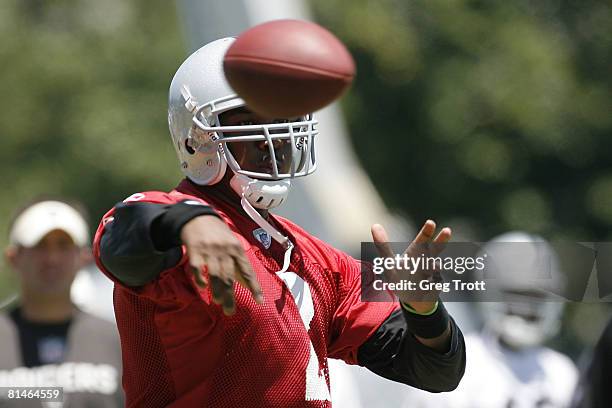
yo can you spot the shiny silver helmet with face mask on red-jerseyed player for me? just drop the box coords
[168,38,318,209]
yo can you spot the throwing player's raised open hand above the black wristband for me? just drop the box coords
[372,220,452,312]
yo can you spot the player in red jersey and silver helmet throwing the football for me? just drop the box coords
[94,38,465,407]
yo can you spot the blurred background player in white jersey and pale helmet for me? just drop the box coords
[402,232,577,408]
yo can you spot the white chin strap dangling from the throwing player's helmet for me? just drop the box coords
[230,174,293,273]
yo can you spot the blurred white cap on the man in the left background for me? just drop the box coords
[9,201,89,247]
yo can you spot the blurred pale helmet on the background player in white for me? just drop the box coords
[479,232,565,349]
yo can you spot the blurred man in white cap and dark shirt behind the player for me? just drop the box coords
[0,200,123,408]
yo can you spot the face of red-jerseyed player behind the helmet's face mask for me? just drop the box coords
[219,108,300,178]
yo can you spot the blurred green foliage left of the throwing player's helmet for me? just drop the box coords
[0,0,185,295]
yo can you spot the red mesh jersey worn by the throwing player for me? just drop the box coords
[94,181,397,408]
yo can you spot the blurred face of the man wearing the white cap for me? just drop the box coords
[7,230,85,294]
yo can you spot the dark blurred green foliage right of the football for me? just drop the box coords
[316,0,612,240]
